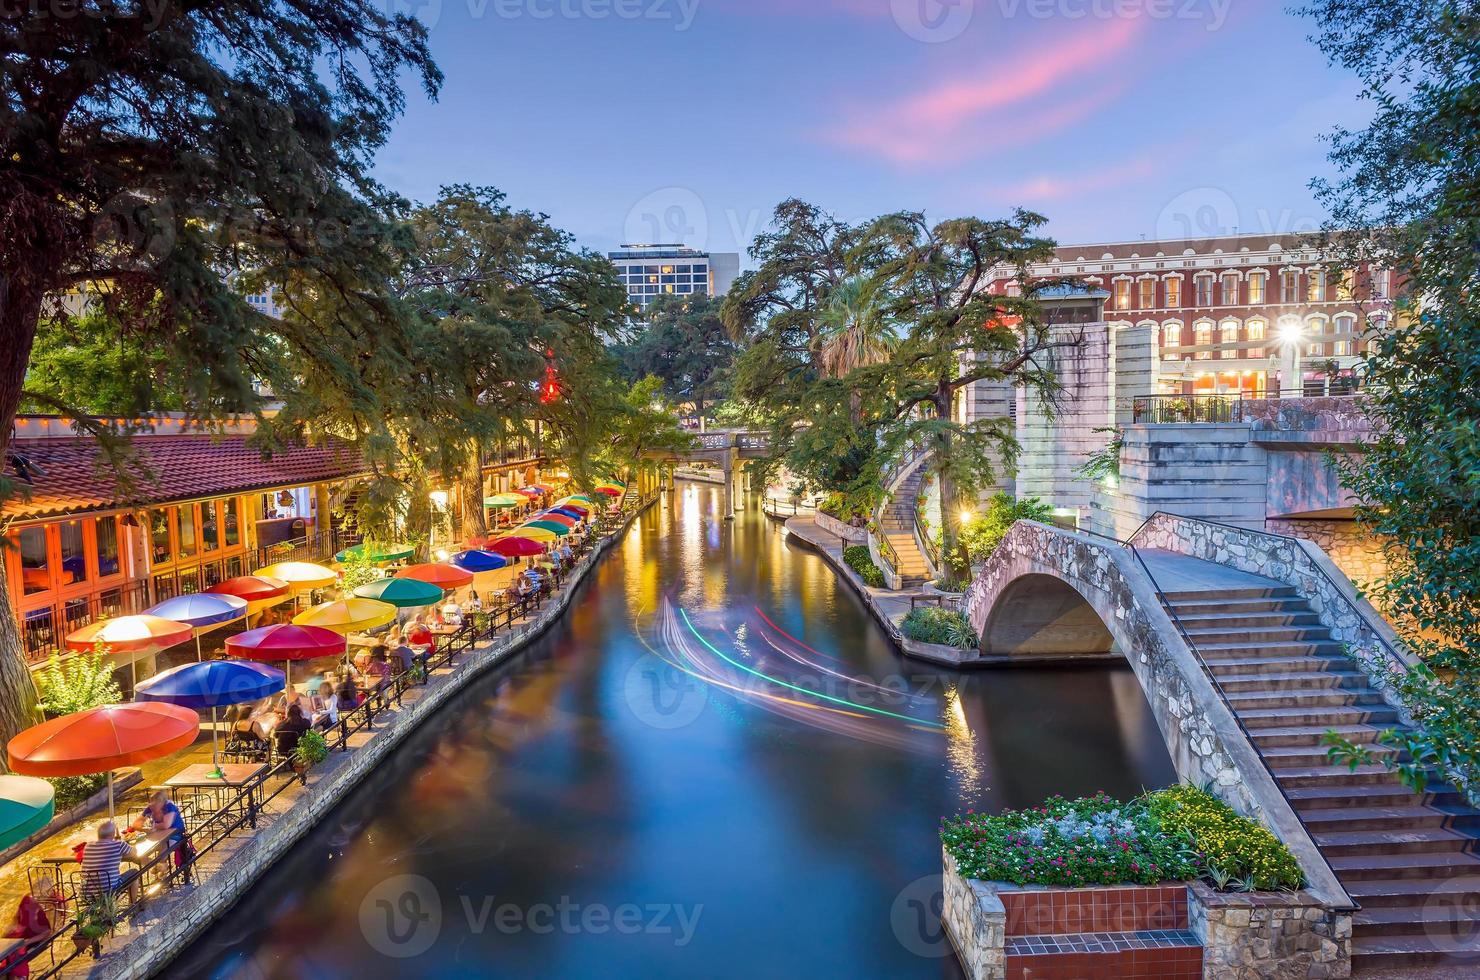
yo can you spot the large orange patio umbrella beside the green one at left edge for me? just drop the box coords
[7,702,200,820]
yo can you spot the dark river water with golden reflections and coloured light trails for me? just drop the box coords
[170,484,1172,977]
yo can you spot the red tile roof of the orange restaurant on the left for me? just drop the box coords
[0,434,367,520]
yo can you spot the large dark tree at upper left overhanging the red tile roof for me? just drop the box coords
[0,0,440,739]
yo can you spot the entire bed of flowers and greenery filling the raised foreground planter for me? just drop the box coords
[940,786,1302,891]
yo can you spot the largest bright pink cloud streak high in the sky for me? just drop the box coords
[824,18,1144,164]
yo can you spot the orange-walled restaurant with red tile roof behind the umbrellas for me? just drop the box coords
[0,416,540,675]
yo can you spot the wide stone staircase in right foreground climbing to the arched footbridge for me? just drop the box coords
[1153,568,1480,976]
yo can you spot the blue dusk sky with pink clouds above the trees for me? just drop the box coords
[377,0,1365,264]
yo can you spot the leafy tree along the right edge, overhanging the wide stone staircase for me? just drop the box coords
[1304,0,1480,791]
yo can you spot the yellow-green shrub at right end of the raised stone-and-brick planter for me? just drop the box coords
[1147,786,1305,891]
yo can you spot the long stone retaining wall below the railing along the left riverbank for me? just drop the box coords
[101,497,657,980]
